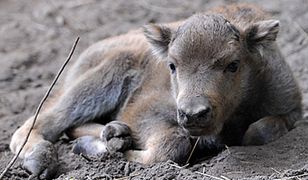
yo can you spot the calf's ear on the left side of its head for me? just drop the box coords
[143,24,172,59]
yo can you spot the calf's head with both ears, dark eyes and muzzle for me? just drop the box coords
[144,14,279,136]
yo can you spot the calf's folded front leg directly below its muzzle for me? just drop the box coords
[125,122,191,164]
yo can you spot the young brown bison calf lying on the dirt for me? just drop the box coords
[10,5,301,178]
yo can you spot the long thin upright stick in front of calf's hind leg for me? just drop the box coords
[0,37,80,180]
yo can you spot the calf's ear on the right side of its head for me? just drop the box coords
[245,20,279,50]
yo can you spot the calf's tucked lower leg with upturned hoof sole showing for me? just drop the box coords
[68,121,132,156]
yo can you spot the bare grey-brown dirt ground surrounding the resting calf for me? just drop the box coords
[0,0,308,179]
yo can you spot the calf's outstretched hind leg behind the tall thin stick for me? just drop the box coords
[10,58,136,176]
